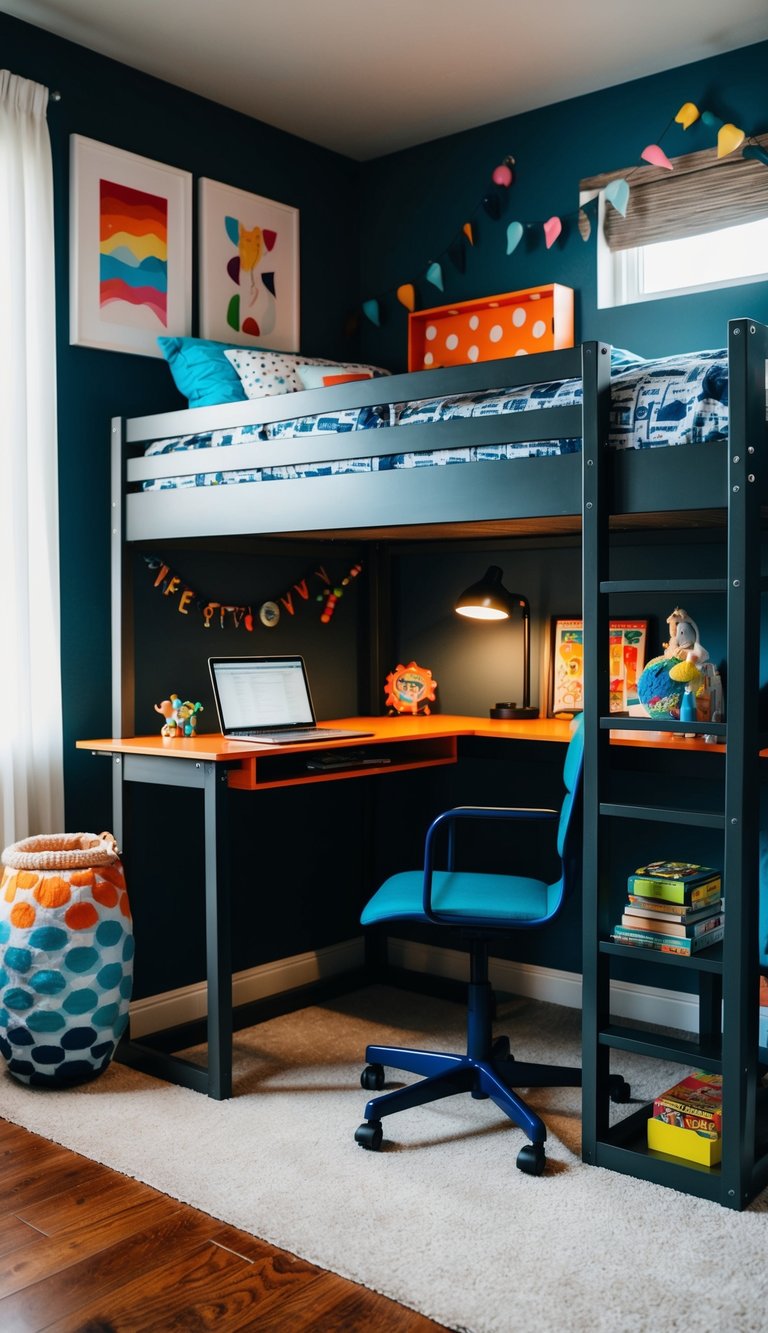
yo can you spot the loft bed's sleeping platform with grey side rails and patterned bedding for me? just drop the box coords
[113,332,740,541]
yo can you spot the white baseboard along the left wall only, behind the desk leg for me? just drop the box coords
[131,937,365,1040]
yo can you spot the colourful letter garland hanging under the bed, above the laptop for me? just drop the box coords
[144,556,363,633]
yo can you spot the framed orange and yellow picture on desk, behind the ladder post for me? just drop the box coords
[547,616,648,717]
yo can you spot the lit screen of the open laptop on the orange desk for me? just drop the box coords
[209,657,315,733]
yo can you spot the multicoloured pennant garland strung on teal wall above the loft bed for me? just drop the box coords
[360,101,768,327]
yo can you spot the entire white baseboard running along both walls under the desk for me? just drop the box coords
[131,937,699,1040]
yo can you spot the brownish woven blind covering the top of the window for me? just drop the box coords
[580,135,768,249]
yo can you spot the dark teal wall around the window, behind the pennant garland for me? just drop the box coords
[361,43,768,369]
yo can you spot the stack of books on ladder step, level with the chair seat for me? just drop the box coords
[611,861,725,956]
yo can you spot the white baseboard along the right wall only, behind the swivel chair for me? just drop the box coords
[387,938,699,1032]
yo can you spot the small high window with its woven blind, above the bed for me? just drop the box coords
[580,136,768,308]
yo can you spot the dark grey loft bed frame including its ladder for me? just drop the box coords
[112,319,768,1208]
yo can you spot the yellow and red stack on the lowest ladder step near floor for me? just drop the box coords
[648,1069,723,1166]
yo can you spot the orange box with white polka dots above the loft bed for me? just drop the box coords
[408,283,573,371]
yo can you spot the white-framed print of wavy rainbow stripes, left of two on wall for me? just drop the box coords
[69,135,192,357]
